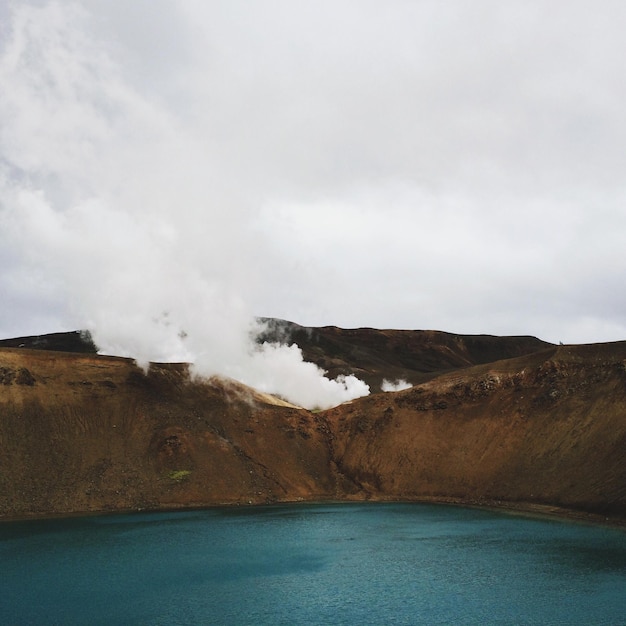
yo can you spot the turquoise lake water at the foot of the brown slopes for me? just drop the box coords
[0,504,626,626]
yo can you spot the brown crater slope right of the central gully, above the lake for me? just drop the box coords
[326,342,626,518]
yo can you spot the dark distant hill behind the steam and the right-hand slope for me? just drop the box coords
[259,318,552,393]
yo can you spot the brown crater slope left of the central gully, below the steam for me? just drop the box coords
[0,349,335,517]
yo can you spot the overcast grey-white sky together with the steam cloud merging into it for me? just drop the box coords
[0,0,626,404]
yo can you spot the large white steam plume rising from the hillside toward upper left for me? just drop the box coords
[0,2,369,408]
